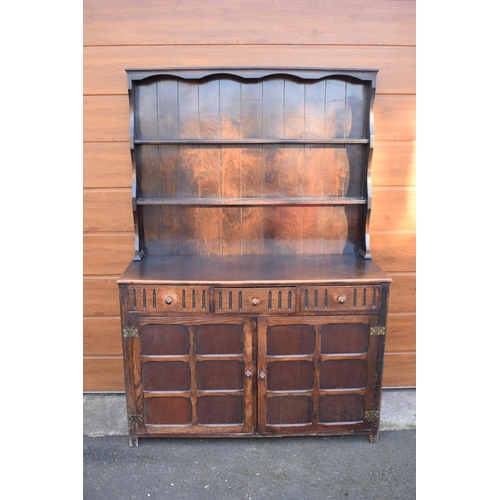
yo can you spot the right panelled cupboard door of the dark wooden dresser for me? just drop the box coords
[257,315,382,434]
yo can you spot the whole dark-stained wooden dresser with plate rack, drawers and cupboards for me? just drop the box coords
[118,68,391,444]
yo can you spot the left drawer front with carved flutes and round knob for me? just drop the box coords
[129,286,210,313]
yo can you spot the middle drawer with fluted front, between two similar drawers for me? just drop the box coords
[214,287,296,314]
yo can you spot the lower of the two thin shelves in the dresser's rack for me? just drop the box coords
[136,197,368,206]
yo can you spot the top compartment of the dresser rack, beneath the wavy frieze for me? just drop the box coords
[131,75,373,145]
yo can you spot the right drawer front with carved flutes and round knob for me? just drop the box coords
[300,285,381,312]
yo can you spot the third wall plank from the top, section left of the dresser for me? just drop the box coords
[83,96,130,142]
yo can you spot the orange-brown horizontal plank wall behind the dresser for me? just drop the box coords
[83,0,416,392]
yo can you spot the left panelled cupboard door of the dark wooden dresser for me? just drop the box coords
[138,317,255,435]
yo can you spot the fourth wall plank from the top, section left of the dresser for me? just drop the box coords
[83,142,132,189]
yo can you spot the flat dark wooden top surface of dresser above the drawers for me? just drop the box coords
[118,254,392,285]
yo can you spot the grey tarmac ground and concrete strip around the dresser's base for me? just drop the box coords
[83,390,416,500]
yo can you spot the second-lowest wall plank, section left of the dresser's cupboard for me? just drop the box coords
[83,318,122,356]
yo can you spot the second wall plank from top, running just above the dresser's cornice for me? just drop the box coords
[83,45,416,95]
